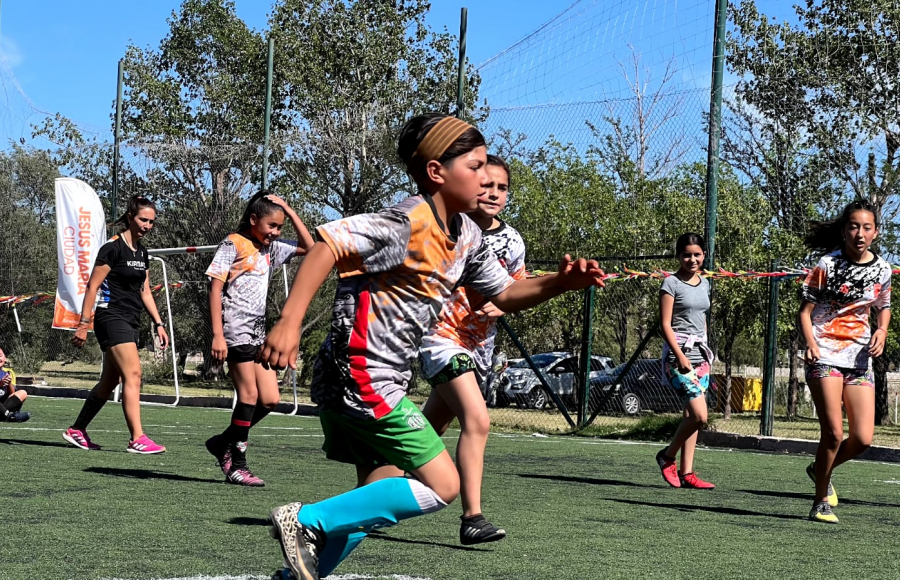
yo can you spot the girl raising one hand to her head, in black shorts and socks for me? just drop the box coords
[206,191,313,487]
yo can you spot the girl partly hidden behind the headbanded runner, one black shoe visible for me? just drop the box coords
[418,155,525,546]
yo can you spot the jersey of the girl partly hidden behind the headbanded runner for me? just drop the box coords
[419,222,527,380]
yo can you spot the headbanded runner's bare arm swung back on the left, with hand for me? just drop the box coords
[256,242,335,369]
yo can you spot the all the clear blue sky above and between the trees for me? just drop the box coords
[0,0,787,141]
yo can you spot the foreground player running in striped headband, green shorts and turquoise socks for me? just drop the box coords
[259,113,602,580]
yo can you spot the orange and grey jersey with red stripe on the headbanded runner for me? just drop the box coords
[312,195,513,419]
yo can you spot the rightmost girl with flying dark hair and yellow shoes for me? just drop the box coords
[800,200,891,523]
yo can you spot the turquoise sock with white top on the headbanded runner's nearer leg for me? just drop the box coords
[297,477,447,545]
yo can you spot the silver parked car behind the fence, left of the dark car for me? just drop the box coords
[497,352,613,409]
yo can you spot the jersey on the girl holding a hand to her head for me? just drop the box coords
[206,234,297,346]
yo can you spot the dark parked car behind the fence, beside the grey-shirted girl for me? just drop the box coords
[591,358,684,415]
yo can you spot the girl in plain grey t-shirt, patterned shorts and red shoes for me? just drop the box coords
[656,233,715,489]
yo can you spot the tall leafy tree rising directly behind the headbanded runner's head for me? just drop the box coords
[270,0,484,216]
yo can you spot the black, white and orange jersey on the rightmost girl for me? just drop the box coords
[802,250,891,369]
